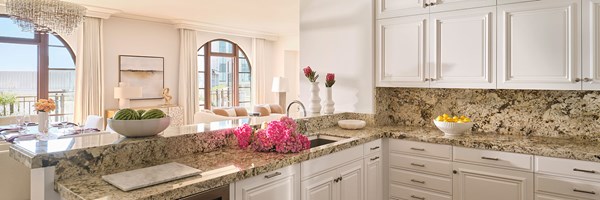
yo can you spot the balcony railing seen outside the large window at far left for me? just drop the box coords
[0,91,75,122]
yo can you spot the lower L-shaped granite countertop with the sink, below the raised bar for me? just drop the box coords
[56,125,600,200]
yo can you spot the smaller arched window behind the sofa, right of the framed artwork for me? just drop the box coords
[198,39,252,109]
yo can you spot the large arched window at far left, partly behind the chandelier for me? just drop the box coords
[0,15,75,121]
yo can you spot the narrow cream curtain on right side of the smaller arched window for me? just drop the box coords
[252,38,271,105]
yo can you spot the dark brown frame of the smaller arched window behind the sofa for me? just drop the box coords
[197,39,252,109]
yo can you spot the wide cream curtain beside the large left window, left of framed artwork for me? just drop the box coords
[74,17,104,123]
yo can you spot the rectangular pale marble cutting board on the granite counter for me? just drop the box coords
[102,162,202,192]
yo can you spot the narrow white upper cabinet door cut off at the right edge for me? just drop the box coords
[582,0,600,90]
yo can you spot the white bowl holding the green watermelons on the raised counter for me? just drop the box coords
[108,117,171,138]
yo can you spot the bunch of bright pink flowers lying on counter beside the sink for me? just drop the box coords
[233,117,310,153]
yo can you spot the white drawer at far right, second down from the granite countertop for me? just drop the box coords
[535,175,600,199]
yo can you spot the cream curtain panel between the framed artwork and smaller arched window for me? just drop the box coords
[178,29,200,124]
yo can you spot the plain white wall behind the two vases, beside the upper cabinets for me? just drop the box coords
[299,0,374,113]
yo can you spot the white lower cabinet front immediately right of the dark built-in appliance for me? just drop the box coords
[235,164,300,200]
